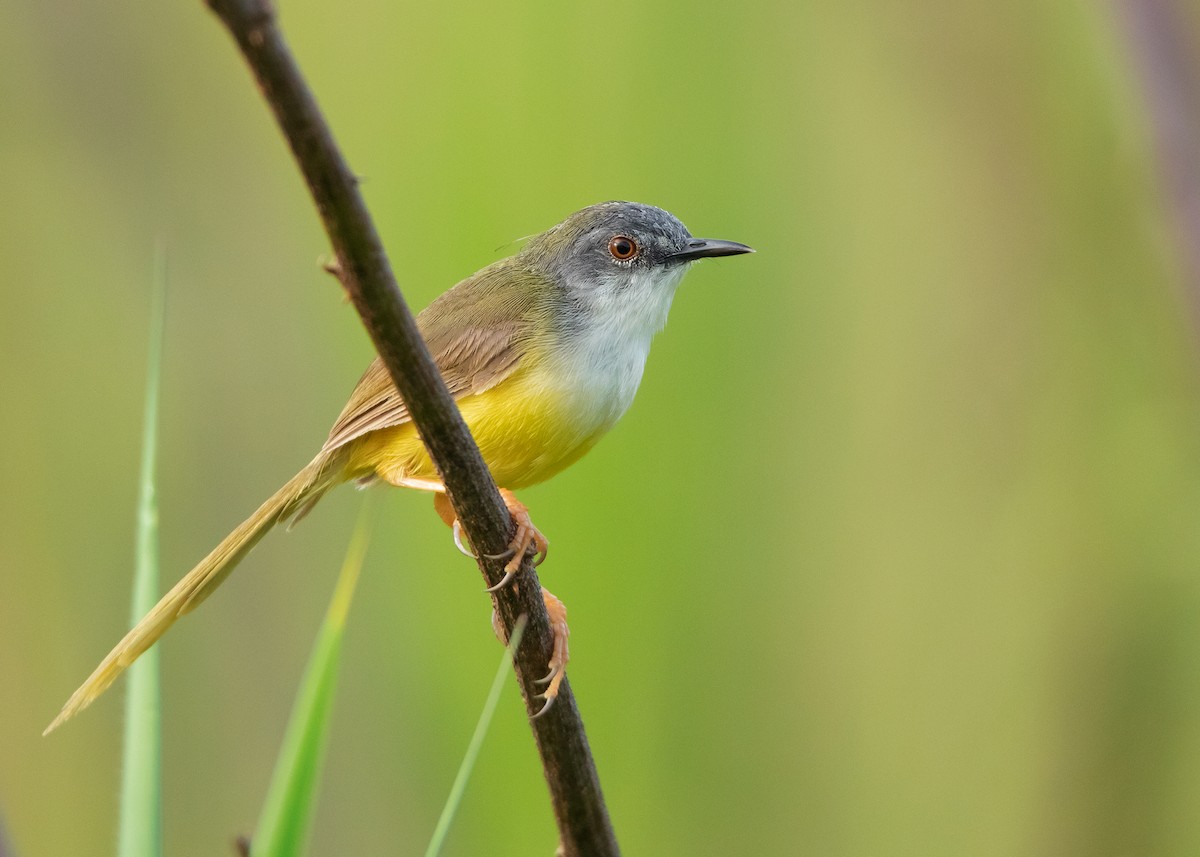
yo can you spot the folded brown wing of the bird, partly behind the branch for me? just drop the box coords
[322,259,540,451]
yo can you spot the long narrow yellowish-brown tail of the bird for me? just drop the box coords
[42,451,344,735]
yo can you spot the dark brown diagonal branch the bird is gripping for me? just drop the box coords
[206,0,619,856]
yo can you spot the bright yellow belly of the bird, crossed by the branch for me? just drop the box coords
[348,370,616,489]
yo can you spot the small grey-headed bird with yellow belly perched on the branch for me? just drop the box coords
[44,202,754,735]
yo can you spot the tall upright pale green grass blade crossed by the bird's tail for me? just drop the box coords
[116,238,167,857]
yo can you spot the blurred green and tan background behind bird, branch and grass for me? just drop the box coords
[0,0,1200,857]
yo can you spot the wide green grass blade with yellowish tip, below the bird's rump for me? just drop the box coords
[250,498,373,857]
